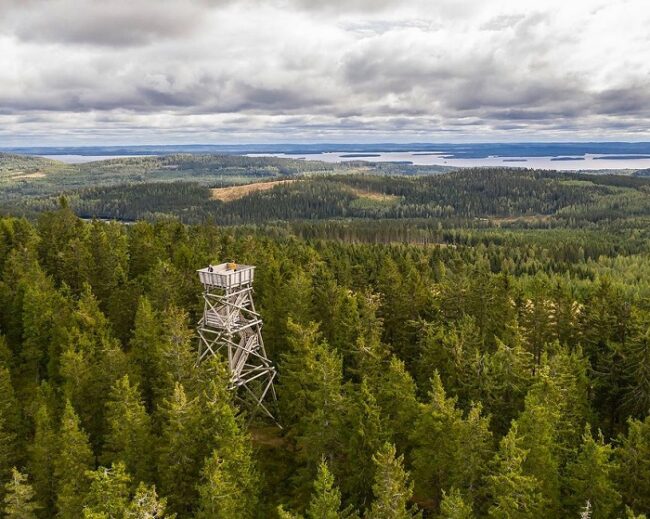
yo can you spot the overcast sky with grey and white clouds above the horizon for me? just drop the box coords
[0,0,650,146]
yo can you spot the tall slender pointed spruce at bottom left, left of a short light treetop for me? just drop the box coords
[54,401,94,519]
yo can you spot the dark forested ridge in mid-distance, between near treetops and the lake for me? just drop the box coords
[10,168,650,226]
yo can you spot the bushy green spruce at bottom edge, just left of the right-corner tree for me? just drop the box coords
[567,425,621,519]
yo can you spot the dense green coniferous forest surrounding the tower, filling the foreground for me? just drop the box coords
[0,164,650,519]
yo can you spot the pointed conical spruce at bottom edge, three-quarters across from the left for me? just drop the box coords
[487,422,544,519]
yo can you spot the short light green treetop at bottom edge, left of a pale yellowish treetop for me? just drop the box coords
[83,463,131,519]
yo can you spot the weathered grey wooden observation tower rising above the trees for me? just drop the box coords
[197,263,276,420]
